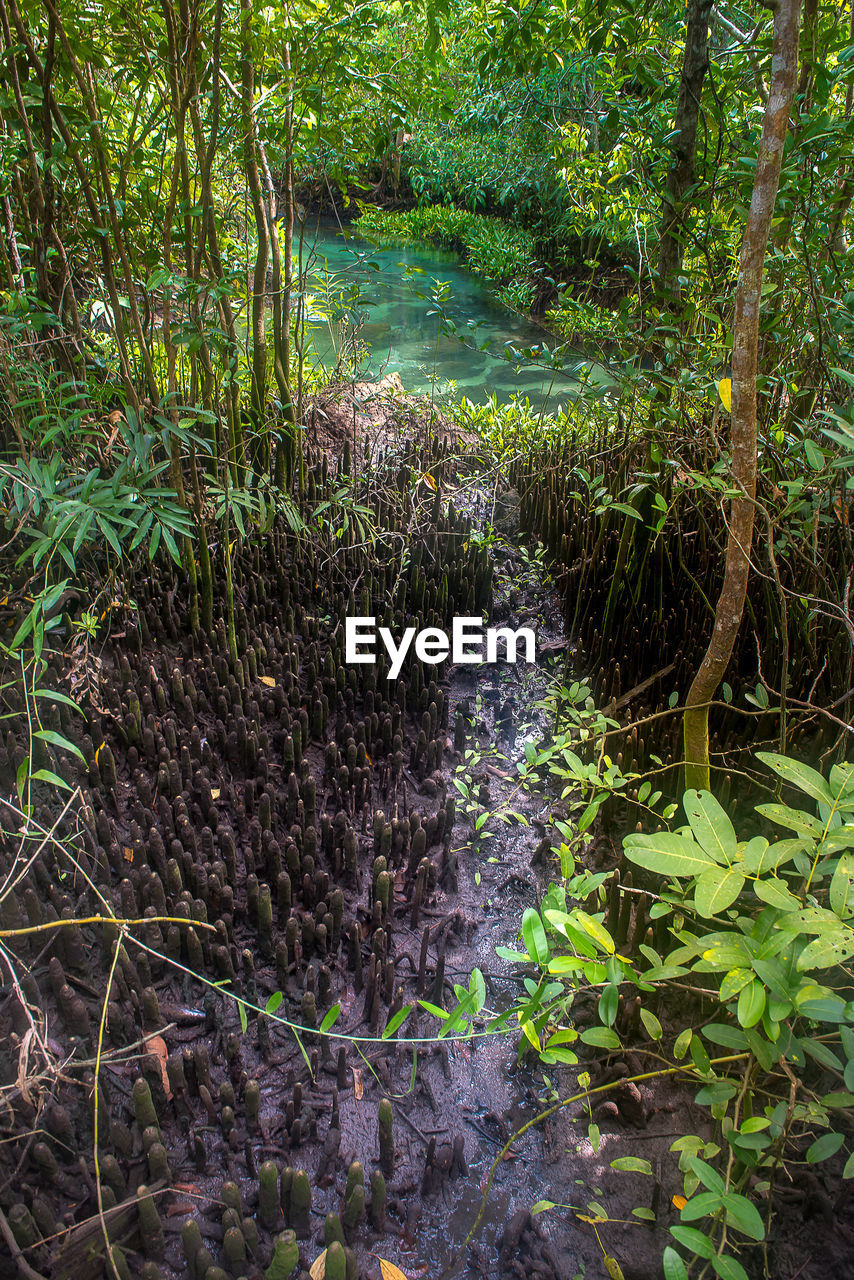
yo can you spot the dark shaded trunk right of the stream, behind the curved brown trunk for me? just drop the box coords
[658,0,712,303]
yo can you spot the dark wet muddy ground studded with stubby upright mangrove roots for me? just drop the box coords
[0,388,850,1280]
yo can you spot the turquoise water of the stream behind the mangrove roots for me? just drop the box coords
[303,229,609,408]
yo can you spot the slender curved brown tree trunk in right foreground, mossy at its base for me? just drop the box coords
[684,0,800,787]
